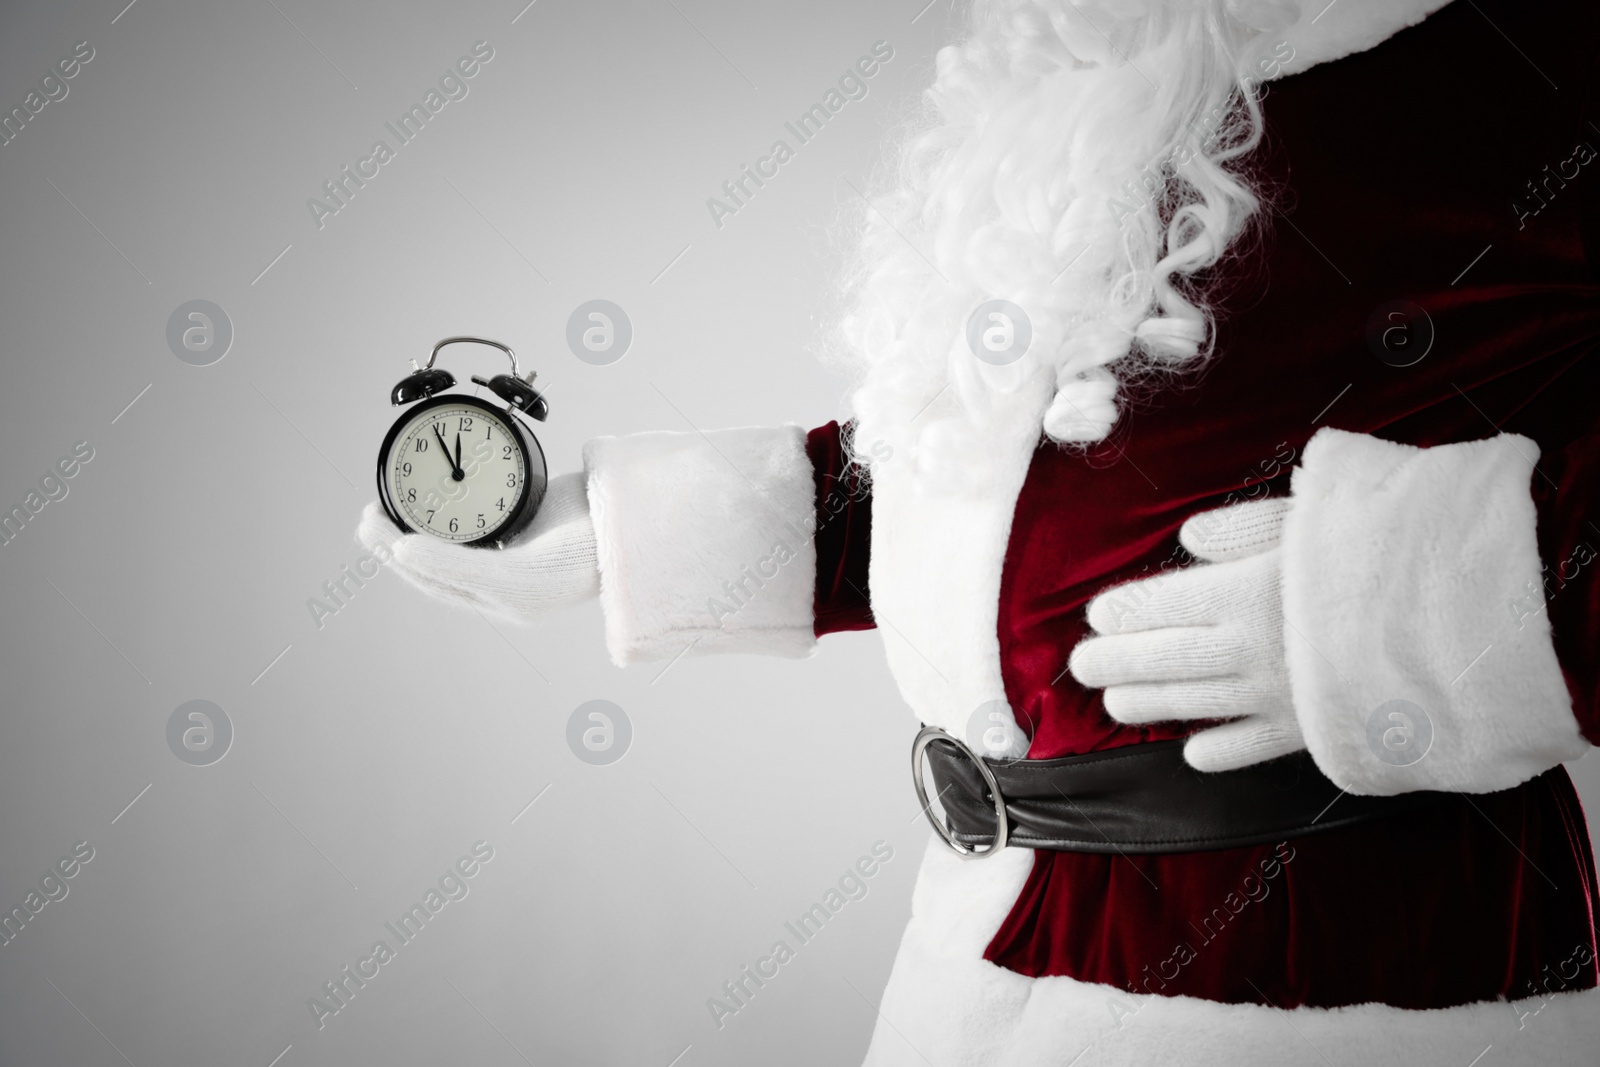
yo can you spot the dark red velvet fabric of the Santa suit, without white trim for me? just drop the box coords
[808,0,1600,1008]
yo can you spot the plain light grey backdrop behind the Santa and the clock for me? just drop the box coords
[0,0,1600,1067]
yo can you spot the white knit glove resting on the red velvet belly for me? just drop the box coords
[1069,499,1306,771]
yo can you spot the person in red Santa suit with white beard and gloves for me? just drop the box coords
[362,0,1600,1067]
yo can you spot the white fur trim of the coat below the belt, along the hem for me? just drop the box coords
[864,840,1600,1067]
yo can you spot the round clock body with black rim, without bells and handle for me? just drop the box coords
[379,397,546,544]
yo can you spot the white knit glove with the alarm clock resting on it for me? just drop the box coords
[357,474,600,621]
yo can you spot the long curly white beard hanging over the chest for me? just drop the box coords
[830,0,1299,478]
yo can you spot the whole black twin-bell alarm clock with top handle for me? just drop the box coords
[378,338,550,547]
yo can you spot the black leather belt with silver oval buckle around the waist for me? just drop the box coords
[910,726,1451,857]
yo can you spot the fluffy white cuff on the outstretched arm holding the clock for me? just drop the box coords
[584,426,816,665]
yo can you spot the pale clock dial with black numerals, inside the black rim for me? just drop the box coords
[389,405,526,541]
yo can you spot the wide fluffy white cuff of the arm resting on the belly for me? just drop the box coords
[1283,429,1589,795]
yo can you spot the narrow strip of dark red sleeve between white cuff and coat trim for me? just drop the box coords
[805,422,877,637]
